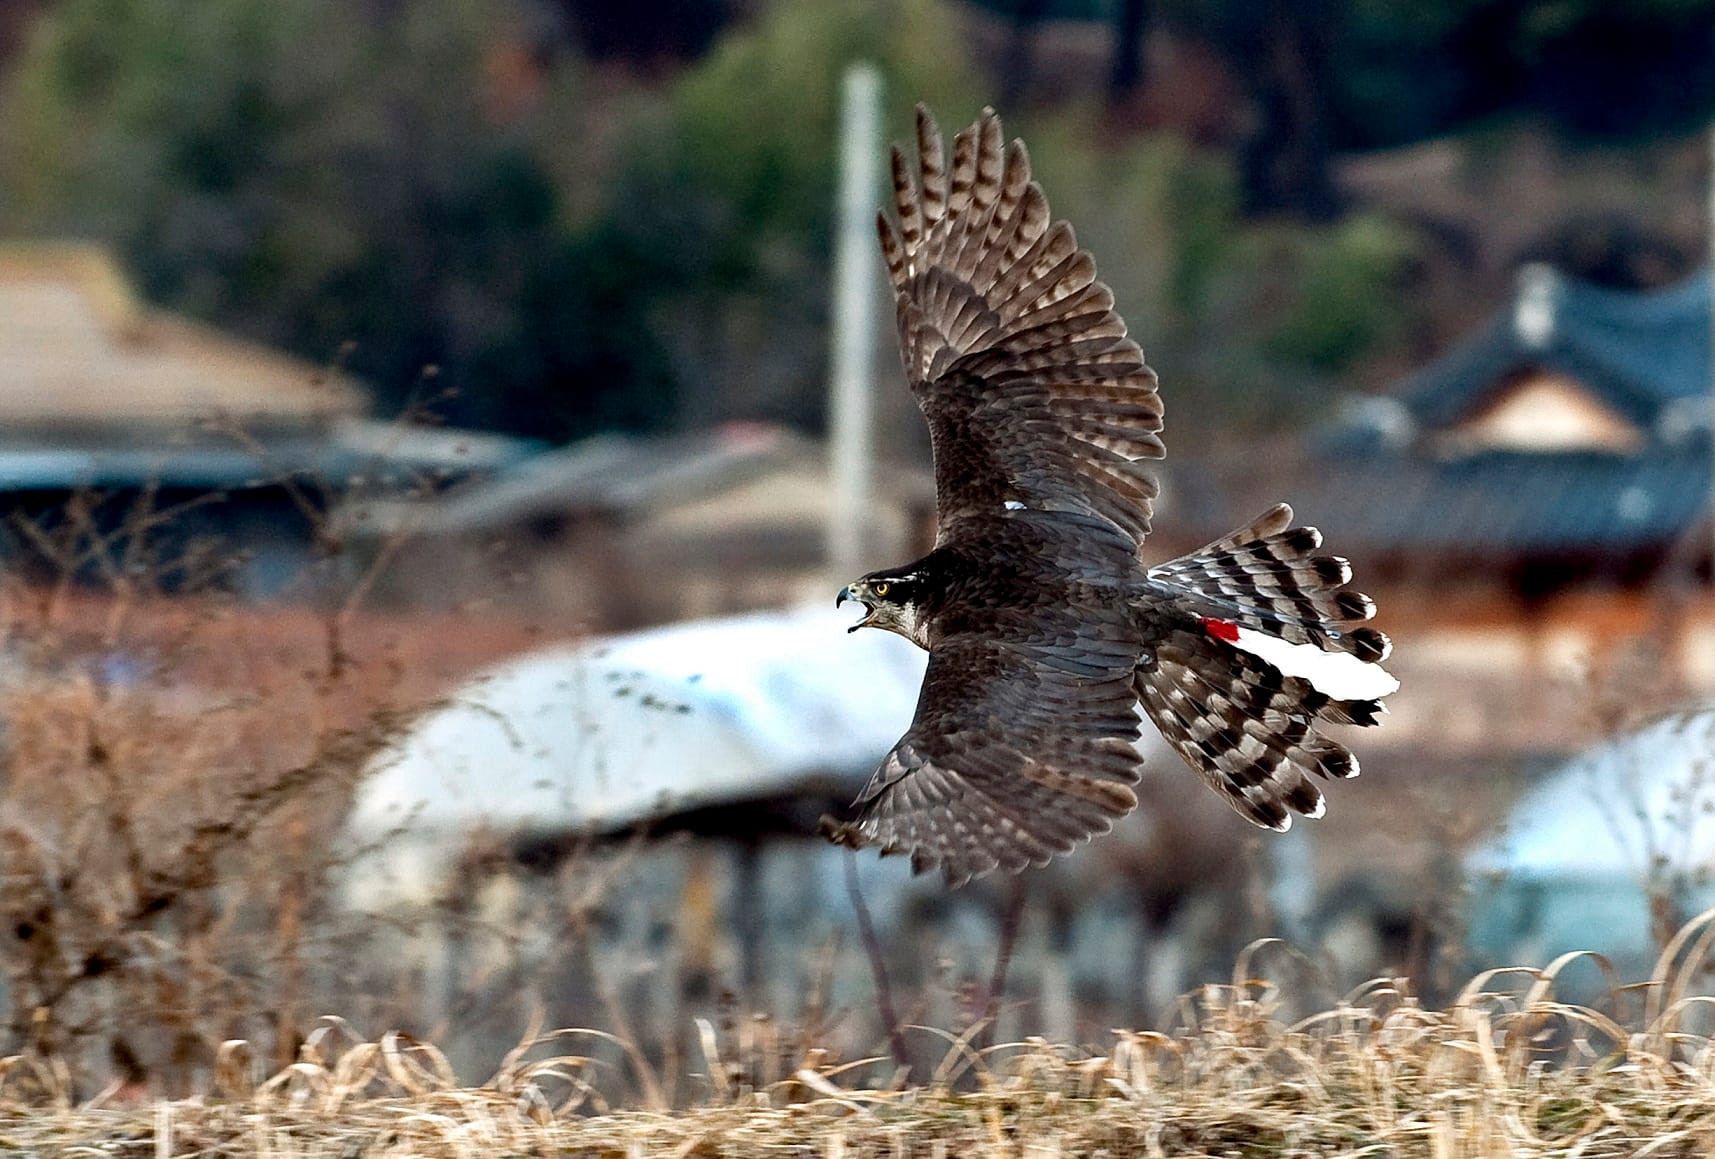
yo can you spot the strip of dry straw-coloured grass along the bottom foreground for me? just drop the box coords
[10,914,1715,1159]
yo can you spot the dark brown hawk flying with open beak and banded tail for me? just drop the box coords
[823,106,1398,885]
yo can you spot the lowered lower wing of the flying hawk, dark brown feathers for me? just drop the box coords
[840,614,1139,885]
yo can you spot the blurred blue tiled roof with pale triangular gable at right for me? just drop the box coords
[1298,266,1715,580]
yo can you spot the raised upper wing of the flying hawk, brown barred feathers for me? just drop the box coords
[880,105,1163,542]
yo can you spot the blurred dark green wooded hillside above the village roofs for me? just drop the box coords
[10,0,1715,441]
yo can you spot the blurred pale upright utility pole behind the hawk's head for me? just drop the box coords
[827,63,882,583]
